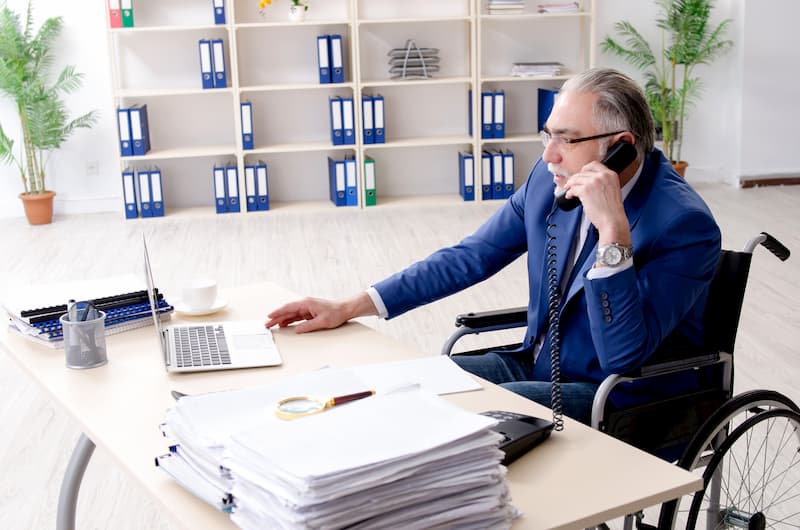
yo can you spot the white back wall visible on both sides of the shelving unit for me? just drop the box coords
[0,0,800,217]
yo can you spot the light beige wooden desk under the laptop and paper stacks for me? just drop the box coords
[0,284,702,529]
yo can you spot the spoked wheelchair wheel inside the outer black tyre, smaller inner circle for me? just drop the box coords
[686,409,800,530]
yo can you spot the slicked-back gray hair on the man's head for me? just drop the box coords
[561,68,655,157]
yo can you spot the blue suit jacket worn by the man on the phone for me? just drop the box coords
[374,150,720,398]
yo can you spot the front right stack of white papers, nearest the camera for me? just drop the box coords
[224,389,516,529]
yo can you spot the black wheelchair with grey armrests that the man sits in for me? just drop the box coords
[442,232,800,530]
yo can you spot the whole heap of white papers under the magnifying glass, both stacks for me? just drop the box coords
[157,359,518,528]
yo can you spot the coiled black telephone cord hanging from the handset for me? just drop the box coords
[545,205,564,431]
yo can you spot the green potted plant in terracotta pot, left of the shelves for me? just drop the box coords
[0,2,96,224]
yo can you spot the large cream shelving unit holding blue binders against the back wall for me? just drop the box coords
[103,0,594,215]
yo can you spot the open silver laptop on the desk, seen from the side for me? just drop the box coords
[142,235,282,372]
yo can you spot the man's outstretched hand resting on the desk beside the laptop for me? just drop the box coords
[266,293,378,333]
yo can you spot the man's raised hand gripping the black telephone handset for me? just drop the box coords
[566,162,631,245]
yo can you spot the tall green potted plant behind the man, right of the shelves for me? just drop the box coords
[600,0,733,176]
